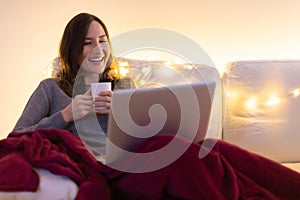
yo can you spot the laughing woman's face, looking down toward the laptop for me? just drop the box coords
[78,21,111,74]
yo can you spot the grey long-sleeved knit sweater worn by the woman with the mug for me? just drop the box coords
[13,78,108,156]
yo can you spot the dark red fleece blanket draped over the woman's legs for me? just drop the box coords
[0,129,300,200]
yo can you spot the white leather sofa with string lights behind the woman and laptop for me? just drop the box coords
[114,59,300,172]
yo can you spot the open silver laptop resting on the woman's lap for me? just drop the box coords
[105,81,216,163]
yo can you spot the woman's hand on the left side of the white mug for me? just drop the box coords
[61,89,93,123]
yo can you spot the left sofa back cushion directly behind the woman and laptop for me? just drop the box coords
[43,57,223,139]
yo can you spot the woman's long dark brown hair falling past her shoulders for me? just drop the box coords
[56,13,117,97]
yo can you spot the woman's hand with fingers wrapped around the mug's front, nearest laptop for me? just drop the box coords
[94,90,112,114]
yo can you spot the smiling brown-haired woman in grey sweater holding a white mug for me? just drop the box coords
[13,13,132,156]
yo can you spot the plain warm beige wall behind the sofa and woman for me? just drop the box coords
[0,0,300,138]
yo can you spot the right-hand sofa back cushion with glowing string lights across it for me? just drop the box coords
[222,60,300,162]
